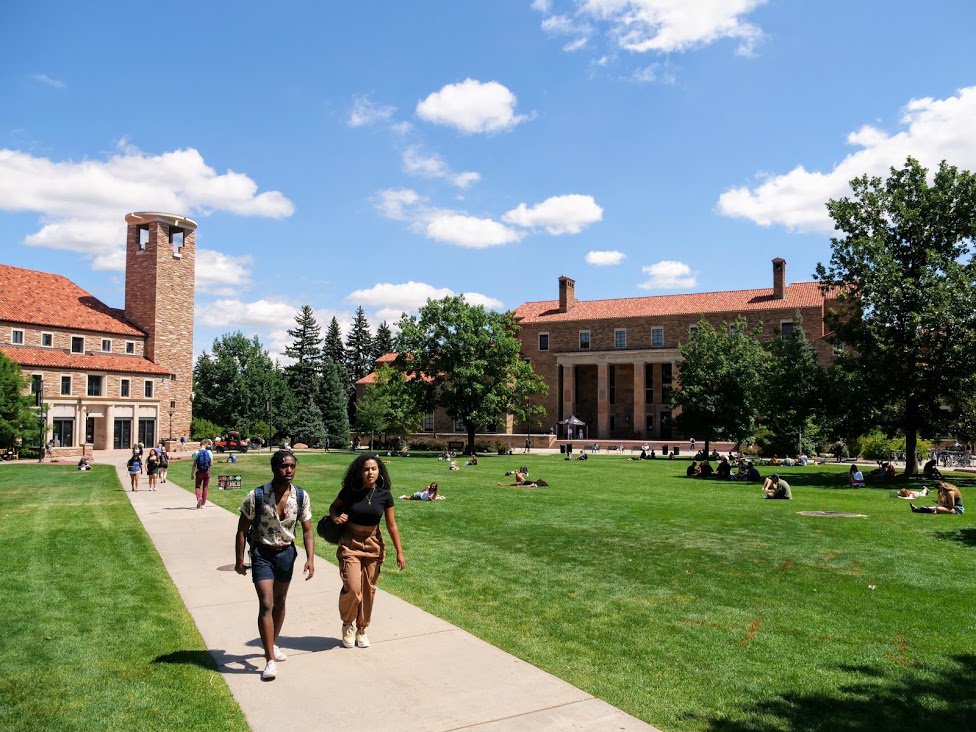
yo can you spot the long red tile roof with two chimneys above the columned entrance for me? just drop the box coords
[514,282,823,323]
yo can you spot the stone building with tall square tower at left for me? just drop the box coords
[0,212,197,455]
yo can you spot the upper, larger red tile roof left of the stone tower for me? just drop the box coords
[0,264,146,337]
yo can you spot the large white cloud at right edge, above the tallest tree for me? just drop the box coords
[718,86,976,231]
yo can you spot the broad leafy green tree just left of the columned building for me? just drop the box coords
[396,296,547,452]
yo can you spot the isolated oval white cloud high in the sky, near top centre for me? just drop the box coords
[417,79,528,134]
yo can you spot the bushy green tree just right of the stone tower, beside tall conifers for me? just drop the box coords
[193,331,294,437]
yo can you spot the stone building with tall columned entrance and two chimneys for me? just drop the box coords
[514,258,833,440]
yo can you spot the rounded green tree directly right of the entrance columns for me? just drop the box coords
[671,319,768,460]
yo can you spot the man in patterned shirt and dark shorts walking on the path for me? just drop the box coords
[234,450,315,681]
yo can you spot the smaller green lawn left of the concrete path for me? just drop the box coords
[0,465,247,730]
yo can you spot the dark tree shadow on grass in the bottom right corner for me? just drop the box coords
[703,654,976,732]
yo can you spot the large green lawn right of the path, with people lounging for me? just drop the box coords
[202,453,976,731]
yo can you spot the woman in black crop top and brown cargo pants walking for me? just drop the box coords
[329,455,407,648]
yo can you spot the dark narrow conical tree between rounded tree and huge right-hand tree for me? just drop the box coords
[762,312,824,455]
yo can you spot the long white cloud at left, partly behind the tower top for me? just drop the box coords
[0,145,294,270]
